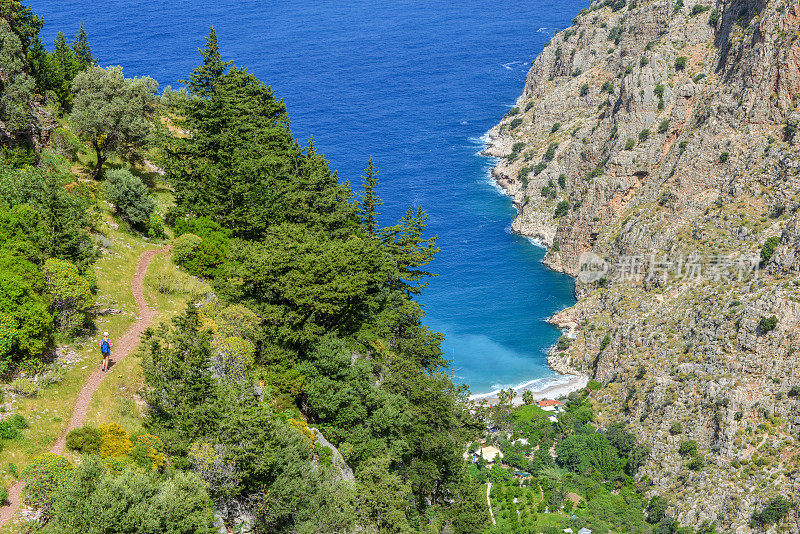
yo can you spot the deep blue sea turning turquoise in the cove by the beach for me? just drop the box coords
[34,0,588,393]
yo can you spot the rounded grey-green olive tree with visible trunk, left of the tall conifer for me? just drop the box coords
[70,67,158,177]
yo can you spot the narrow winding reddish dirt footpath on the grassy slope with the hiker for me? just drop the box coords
[0,247,170,526]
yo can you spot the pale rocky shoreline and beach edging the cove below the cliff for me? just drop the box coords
[469,126,589,406]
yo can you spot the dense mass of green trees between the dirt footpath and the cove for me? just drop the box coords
[144,30,487,532]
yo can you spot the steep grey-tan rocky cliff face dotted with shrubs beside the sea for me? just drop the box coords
[487,0,800,532]
